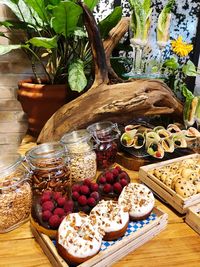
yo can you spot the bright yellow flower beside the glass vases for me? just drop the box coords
[171,36,193,57]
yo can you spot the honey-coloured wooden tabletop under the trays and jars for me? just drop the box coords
[0,136,200,267]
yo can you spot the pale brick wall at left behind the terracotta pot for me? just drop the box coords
[0,5,28,154]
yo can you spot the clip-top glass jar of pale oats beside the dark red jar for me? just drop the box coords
[61,129,97,183]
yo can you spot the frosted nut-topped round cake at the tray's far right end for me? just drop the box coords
[118,183,155,221]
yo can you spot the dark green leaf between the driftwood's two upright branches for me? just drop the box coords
[98,6,122,39]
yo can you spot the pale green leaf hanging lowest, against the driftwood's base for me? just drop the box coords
[68,59,87,92]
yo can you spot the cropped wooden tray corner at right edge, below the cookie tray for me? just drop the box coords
[185,204,200,234]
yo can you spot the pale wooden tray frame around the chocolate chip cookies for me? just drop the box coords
[139,154,200,214]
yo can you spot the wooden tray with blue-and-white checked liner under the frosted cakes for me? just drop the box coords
[32,208,168,267]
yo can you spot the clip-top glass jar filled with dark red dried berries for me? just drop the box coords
[87,121,120,170]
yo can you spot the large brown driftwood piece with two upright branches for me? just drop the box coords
[38,4,183,143]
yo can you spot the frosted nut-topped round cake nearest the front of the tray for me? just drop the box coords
[56,213,103,266]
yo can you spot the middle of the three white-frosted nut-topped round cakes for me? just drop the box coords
[90,200,129,241]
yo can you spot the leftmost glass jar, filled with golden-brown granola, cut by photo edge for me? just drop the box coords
[0,153,32,233]
